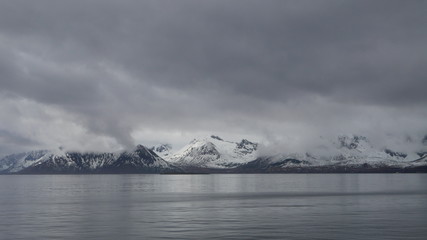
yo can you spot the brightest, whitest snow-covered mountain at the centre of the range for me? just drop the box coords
[165,135,258,169]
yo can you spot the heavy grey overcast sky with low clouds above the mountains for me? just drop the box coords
[0,0,427,155]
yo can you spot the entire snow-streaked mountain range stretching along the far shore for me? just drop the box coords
[0,135,427,174]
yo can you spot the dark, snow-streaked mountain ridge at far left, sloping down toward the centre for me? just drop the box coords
[0,145,178,173]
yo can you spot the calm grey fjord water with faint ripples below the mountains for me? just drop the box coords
[0,174,427,240]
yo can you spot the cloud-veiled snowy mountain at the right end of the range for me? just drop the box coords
[241,135,427,172]
